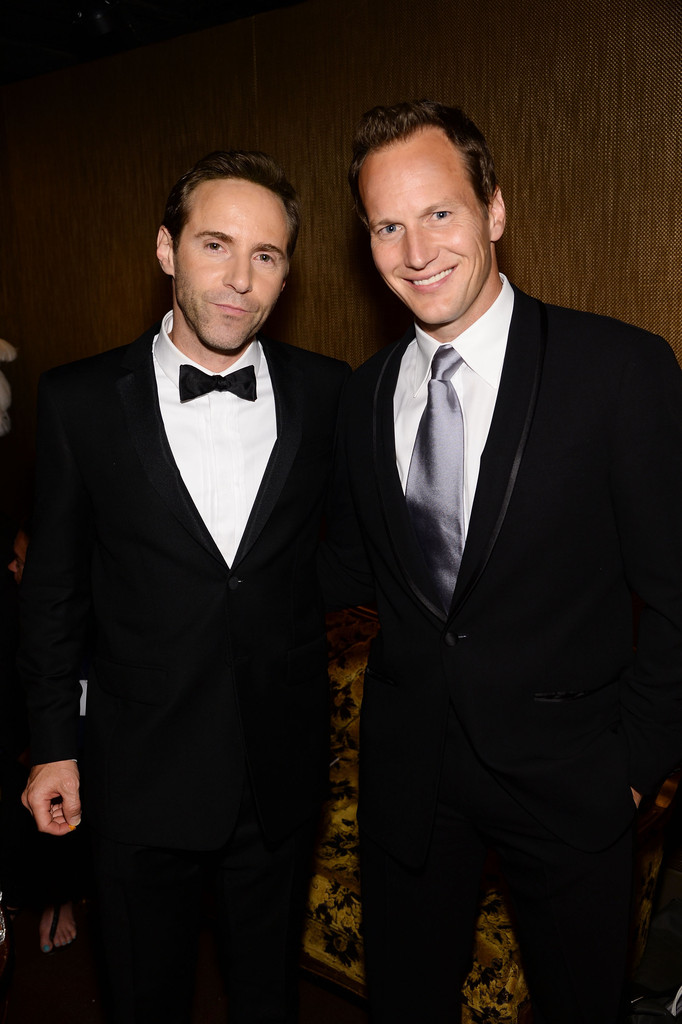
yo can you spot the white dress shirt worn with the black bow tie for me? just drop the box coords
[154,311,276,565]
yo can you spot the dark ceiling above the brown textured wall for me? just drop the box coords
[0,0,296,85]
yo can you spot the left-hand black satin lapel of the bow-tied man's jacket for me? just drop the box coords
[116,328,225,565]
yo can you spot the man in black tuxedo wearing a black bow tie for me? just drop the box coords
[20,151,348,1024]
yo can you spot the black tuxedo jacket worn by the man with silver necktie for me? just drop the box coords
[323,291,682,864]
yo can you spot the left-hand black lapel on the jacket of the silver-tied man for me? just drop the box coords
[373,328,445,622]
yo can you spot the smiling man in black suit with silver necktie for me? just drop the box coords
[323,100,682,1024]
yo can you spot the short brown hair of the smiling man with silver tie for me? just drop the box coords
[348,99,498,227]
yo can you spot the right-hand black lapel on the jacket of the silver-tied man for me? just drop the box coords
[449,289,547,618]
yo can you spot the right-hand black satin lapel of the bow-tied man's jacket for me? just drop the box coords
[235,338,301,565]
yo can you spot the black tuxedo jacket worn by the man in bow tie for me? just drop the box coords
[20,329,349,849]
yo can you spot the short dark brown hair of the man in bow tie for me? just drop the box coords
[163,150,301,258]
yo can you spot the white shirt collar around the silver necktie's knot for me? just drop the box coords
[414,273,514,395]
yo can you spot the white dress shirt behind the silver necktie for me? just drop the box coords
[393,273,514,537]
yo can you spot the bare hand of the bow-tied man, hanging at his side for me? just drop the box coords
[22,761,81,836]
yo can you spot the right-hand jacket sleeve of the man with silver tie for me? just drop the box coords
[611,338,682,793]
